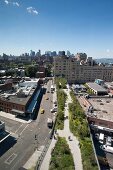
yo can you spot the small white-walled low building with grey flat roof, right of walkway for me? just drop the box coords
[86,82,108,95]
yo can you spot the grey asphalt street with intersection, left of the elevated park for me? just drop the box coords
[0,81,53,170]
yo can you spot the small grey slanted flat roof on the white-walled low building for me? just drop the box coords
[87,82,107,92]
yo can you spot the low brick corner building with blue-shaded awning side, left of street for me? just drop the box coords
[0,79,41,116]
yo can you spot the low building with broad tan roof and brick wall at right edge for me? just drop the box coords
[85,98,113,131]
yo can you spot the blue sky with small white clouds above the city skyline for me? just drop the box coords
[0,0,113,58]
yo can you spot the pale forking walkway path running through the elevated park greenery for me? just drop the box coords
[40,89,83,170]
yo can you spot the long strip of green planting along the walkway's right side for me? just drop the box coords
[69,92,98,170]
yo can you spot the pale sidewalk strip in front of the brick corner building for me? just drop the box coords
[0,111,32,123]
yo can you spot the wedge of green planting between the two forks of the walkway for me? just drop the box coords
[49,137,75,170]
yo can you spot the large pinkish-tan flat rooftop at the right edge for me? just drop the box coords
[88,98,113,121]
